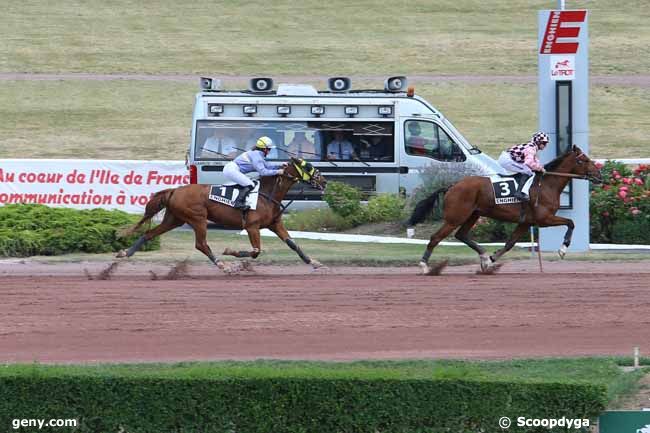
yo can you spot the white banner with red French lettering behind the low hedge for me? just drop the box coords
[0,159,190,213]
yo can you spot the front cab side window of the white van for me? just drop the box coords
[404,120,466,162]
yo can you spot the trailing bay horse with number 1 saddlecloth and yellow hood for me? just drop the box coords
[117,157,327,273]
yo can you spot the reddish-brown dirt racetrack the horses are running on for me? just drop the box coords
[0,260,650,362]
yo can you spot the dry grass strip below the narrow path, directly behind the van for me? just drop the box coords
[0,79,650,160]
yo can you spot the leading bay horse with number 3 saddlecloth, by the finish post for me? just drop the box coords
[407,146,602,274]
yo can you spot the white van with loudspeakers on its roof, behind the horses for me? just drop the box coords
[187,77,499,204]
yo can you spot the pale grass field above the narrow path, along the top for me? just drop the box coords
[0,0,650,75]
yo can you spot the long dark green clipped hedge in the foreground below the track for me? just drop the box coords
[0,373,606,433]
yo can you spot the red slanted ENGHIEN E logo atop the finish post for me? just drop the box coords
[539,11,587,54]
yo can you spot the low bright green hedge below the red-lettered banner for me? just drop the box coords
[0,204,160,257]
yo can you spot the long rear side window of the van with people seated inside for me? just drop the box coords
[193,120,395,162]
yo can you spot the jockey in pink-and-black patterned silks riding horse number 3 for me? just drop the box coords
[499,132,548,201]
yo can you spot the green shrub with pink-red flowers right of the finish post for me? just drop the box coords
[590,161,650,244]
